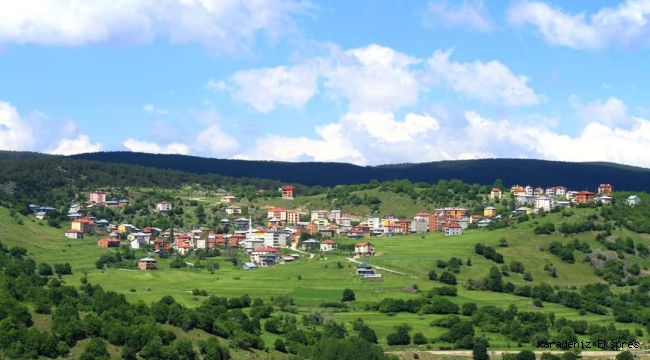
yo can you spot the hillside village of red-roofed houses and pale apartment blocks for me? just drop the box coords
[24,184,640,277]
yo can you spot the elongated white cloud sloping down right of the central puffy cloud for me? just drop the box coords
[427,50,546,106]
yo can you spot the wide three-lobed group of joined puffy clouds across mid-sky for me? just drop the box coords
[215,44,545,113]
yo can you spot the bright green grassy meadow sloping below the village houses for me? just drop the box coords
[0,202,650,358]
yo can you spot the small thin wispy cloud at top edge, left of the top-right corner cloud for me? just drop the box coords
[423,0,493,31]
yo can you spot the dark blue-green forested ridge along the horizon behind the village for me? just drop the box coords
[71,152,650,191]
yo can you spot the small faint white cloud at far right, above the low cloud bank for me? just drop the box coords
[569,95,633,126]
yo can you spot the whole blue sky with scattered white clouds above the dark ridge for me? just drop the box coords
[0,0,650,167]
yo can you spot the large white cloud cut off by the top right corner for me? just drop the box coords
[508,0,650,49]
